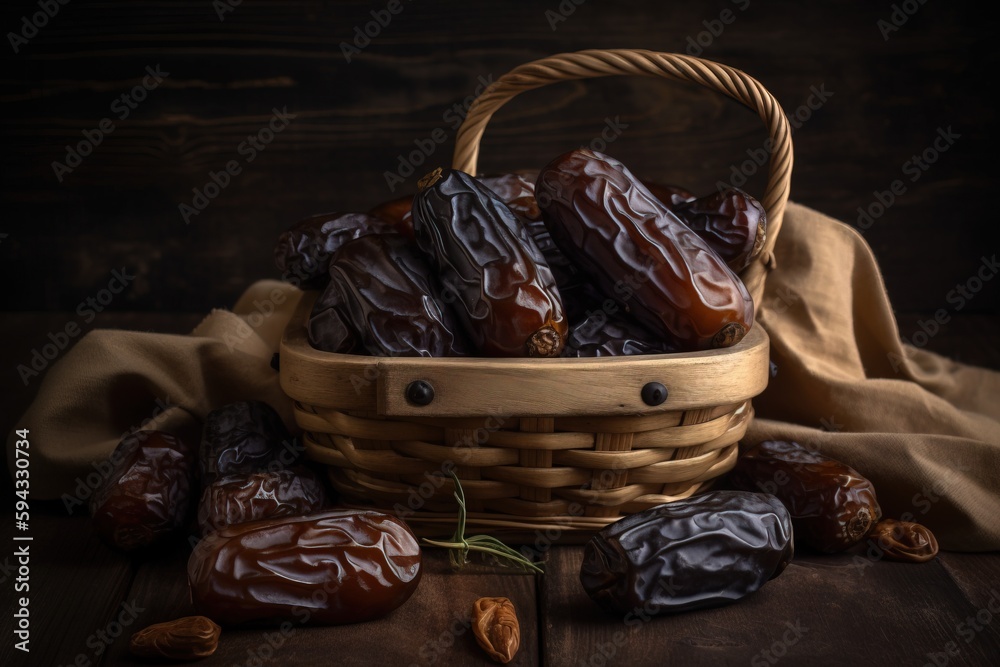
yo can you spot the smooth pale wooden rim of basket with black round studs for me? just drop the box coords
[280,292,770,417]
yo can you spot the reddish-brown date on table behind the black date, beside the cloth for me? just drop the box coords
[729,440,882,553]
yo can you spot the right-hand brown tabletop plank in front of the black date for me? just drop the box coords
[541,547,1000,667]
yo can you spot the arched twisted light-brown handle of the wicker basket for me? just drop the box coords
[452,49,792,304]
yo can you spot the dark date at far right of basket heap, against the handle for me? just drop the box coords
[674,188,767,272]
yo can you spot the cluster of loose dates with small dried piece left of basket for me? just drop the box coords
[90,401,421,636]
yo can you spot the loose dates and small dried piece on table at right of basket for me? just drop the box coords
[580,441,938,618]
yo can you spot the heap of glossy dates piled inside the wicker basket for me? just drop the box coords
[275,149,765,357]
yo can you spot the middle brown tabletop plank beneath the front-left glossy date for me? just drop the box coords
[104,549,540,667]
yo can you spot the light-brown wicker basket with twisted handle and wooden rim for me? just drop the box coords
[281,50,792,541]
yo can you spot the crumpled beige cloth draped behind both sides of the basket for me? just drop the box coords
[8,204,1000,551]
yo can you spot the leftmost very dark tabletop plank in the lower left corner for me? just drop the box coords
[0,516,135,667]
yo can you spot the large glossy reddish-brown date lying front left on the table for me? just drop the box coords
[188,510,421,626]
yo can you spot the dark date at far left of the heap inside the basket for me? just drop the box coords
[274,213,394,289]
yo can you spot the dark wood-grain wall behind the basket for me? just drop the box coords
[0,0,1000,326]
